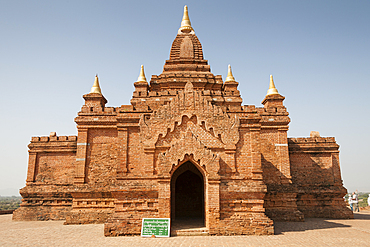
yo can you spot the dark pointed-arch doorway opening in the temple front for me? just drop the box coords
[171,161,204,225]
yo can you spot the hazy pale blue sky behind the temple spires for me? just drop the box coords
[0,0,370,195]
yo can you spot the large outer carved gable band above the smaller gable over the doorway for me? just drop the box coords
[140,82,240,150]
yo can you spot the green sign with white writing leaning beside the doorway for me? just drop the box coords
[141,218,171,237]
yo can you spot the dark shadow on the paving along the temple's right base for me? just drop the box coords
[274,218,350,235]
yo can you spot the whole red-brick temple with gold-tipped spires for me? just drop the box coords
[13,6,353,236]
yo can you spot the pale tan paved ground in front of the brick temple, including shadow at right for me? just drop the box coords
[0,211,370,247]
